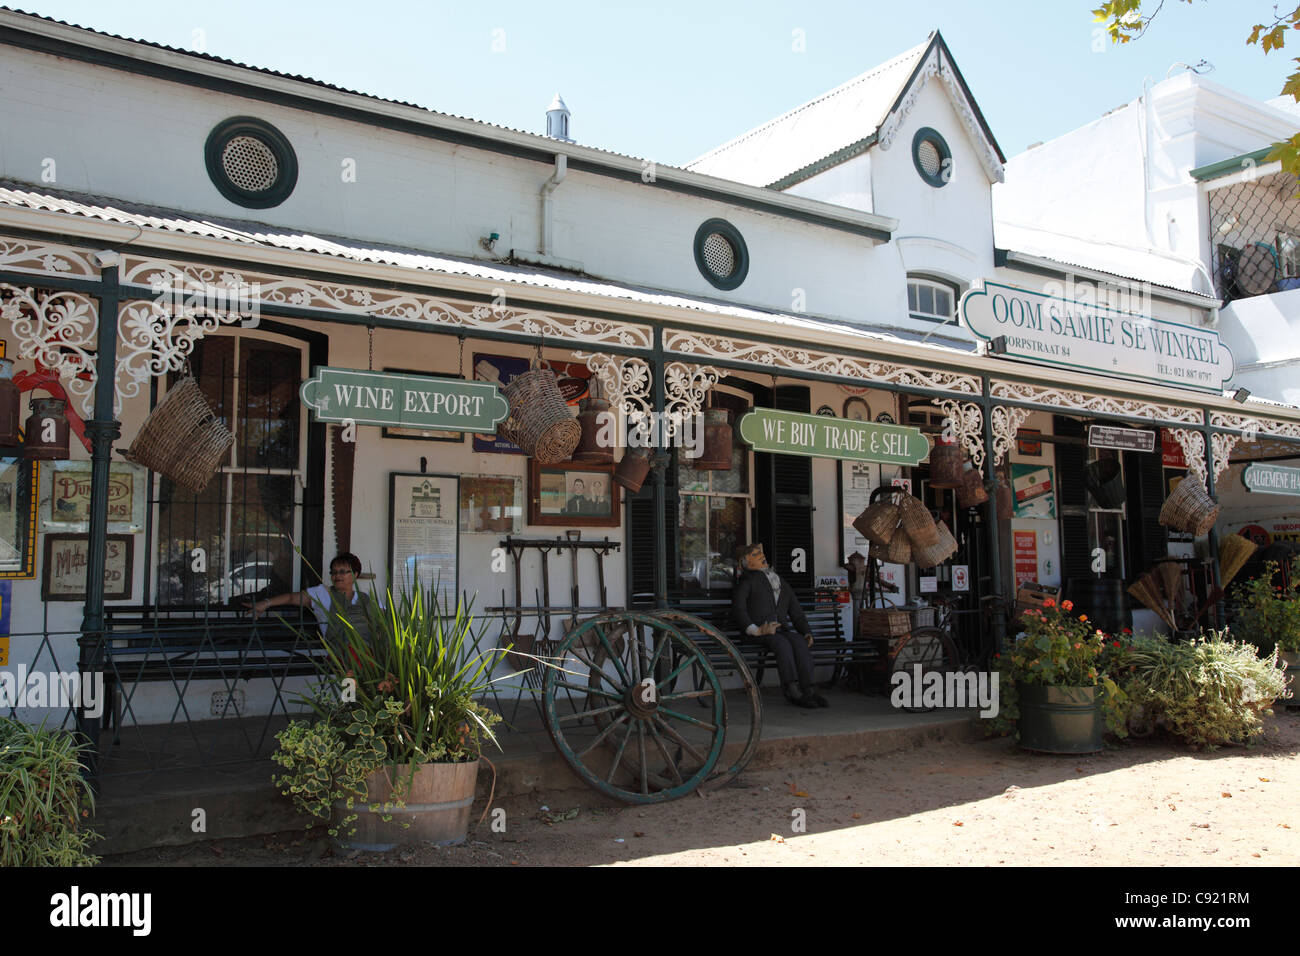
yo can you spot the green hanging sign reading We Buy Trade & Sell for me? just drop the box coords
[740,408,930,466]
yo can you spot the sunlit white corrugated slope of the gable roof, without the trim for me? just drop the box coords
[685,34,935,186]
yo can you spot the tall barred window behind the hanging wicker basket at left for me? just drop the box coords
[151,334,307,606]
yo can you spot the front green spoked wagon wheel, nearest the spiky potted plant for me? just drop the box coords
[542,611,727,804]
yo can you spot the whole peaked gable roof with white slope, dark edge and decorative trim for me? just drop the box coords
[685,30,1006,190]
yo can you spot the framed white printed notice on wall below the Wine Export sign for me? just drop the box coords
[389,471,460,606]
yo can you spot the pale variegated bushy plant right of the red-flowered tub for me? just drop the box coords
[1115,631,1291,748]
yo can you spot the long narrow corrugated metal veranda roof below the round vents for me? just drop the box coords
[0,181,969,348]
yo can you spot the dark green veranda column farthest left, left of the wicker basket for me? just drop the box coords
[78,252,121,765]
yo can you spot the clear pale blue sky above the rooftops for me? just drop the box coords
[9,0,1300,165]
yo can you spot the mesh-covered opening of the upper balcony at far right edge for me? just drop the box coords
[1208,172,1300,302]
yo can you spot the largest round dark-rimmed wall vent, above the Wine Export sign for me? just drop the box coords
[204,116,298,209]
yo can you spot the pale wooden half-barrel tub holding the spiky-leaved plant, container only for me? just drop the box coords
[334,761,478,852]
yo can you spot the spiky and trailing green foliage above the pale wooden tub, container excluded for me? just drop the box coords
[273,588,506,836]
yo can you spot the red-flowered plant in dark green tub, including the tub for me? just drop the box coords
[998,598,1122,753]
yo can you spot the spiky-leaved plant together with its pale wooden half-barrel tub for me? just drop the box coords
[273,587,504,849]
